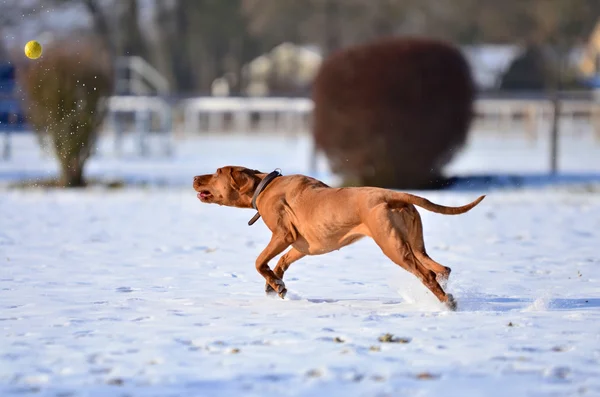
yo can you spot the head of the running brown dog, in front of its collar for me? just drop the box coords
[193,166,263,208]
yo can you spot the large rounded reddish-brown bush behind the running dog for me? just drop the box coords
[313,38,474,189]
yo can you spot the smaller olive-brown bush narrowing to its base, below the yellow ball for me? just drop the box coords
[18,39,113,187]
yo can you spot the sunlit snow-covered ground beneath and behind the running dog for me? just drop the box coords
[0,131,600,397]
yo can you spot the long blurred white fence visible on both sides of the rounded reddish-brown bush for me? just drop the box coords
[172,97,600,140]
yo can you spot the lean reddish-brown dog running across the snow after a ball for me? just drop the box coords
[193,166,485,309]
